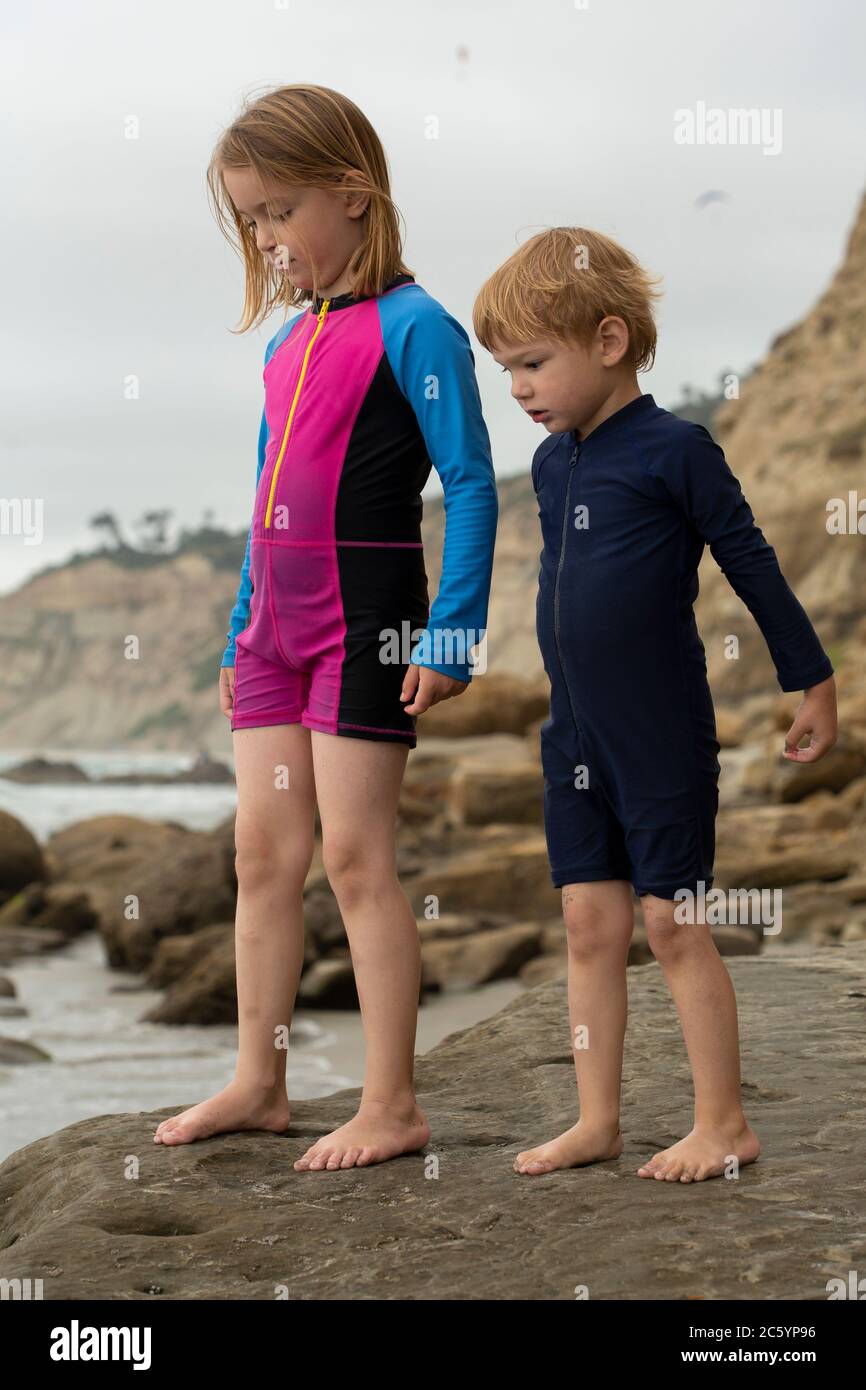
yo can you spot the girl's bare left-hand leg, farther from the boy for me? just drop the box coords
[154,724,316,1144]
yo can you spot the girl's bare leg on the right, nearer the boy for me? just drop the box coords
[295,731,430,1172]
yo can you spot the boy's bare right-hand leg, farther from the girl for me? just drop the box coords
[638,894,760,1183]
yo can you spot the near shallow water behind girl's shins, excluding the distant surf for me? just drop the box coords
[0,933,523,1162]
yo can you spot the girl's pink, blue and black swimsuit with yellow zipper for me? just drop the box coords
[221,274,498,748]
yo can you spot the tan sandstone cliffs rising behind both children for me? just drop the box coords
[0,186,866,752]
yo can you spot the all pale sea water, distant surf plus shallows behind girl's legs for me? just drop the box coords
[0,749,523,1161]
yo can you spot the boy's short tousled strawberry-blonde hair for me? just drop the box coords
[473,227,660,371]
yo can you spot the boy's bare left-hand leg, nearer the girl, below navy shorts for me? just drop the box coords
[514,878,634,1176]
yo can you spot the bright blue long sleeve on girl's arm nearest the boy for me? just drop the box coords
[379,286,499,681]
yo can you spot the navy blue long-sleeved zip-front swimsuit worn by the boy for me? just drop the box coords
[532,395,833,898]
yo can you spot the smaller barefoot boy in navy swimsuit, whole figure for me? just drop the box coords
[473,227,837,1182]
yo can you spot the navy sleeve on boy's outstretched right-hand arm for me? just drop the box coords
[649,424,833,691]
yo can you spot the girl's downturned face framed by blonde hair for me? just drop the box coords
[222,168,370,295]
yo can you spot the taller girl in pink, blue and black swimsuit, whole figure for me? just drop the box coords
[154,85,498,1170]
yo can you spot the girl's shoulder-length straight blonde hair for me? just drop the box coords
[207,82,413,332]
